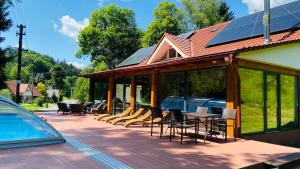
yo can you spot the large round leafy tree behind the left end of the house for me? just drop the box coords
[77,4,141,69]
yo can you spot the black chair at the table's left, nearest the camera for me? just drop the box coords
[169,109,197,144]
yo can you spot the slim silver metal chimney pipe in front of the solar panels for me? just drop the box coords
[263,0,271,45]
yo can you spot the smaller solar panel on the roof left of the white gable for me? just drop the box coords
[117,46,155,67]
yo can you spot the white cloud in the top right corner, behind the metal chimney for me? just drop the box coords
[242,0,296,13]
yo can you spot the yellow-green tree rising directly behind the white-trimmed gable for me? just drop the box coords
[142,1,186,47]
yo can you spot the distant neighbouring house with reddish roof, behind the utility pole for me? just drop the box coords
[5,81,42,103]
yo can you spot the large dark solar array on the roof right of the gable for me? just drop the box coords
[207,1,300,47]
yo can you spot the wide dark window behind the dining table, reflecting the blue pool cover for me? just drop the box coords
[158,67,226,112]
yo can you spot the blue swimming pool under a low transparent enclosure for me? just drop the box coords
[0,96,65,148]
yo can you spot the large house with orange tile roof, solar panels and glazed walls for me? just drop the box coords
[83,1,300,143]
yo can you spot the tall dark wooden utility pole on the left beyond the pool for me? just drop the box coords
[16,24,26,104]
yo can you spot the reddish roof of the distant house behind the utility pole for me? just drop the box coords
[5,81,42,97]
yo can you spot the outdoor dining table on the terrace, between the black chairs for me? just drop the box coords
[182,112,220,143]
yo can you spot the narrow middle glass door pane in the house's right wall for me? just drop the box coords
[265,73,280,131]
